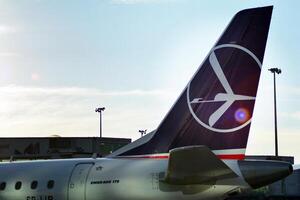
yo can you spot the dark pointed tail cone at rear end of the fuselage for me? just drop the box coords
[238,160,293,189]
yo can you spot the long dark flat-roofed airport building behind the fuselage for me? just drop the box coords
[0,136,131,161]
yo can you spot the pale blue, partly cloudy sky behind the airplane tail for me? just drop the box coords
[0,0,300,163]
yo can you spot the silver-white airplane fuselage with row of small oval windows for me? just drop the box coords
[0,158,249,200]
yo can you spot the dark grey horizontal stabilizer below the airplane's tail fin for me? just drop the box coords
[162,146,237,185]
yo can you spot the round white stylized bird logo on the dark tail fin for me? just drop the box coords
[187,44,262,133]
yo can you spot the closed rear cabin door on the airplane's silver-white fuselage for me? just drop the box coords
[68,163,94,200]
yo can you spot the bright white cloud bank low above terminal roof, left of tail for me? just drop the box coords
[0,85,174,138]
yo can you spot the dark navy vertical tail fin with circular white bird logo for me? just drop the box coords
[113,6,273,159]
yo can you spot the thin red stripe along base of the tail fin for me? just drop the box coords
[117,154,245,160]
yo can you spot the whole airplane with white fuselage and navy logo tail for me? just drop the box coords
[0,6,293,200]
